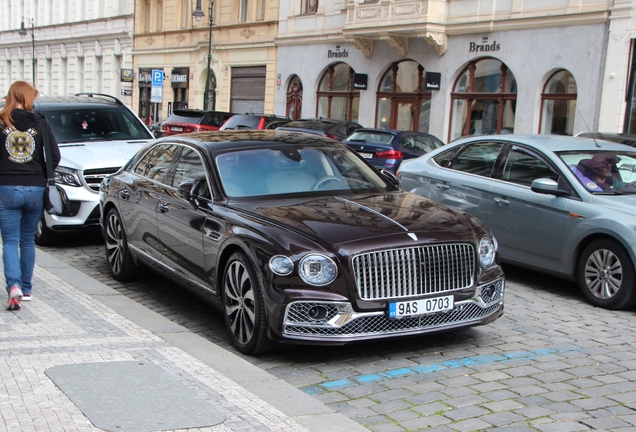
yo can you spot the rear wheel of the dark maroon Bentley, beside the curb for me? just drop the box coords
[104,208,140,281]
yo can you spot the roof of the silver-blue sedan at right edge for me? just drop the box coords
[450,134,634,152]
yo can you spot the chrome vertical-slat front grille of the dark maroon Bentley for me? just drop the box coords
[353,243,475,300]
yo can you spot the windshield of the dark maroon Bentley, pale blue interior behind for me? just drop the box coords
[216,146,393,197]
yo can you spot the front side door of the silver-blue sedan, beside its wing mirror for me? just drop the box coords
[487,145,570,270]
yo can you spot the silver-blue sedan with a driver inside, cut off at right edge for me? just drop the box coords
[398,135,636,309]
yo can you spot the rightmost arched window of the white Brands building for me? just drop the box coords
[539,70,576,135]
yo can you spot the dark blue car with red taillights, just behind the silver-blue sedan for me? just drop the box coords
[343,128,444,173]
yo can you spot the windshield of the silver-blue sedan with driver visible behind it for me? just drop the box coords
[558,150,636,193]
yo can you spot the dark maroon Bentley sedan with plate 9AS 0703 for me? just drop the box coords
[100,130,504,354]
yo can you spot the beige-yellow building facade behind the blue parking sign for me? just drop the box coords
[133,0,278,125]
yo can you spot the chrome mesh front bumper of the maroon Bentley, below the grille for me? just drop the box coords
[282,277,505,344]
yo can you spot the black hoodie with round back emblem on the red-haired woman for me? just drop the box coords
[0,108,60,186]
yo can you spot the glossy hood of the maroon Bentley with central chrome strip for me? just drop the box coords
[233,192,485,246]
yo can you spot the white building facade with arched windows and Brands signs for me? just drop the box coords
[276,0,620,141]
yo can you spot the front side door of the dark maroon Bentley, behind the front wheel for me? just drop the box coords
[157,146,211,284]
